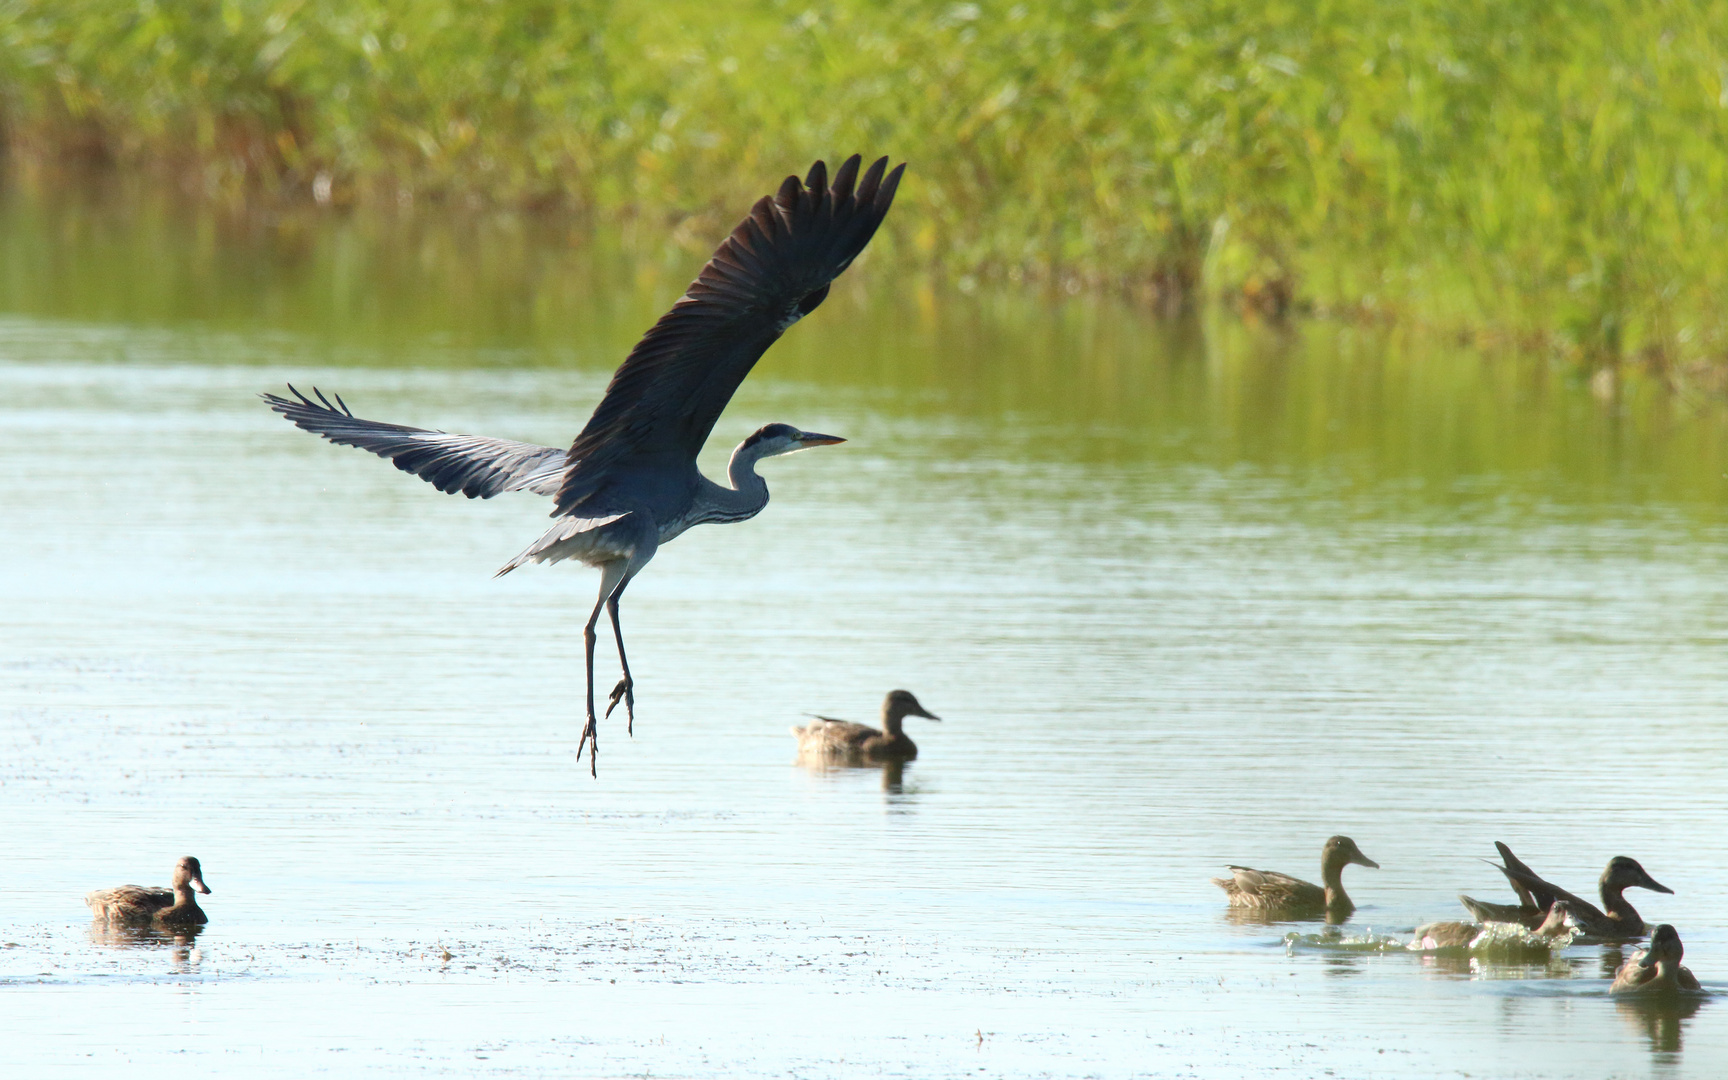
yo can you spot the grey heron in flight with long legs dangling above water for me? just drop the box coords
[263,154,905,776]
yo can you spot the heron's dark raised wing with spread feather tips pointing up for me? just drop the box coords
[553,154,905,515]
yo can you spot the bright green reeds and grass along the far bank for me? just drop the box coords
[0,0,1728,377]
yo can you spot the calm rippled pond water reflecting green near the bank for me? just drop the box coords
[0,177,1728,1078]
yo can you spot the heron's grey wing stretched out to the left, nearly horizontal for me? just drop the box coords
[259,385,567,499]
